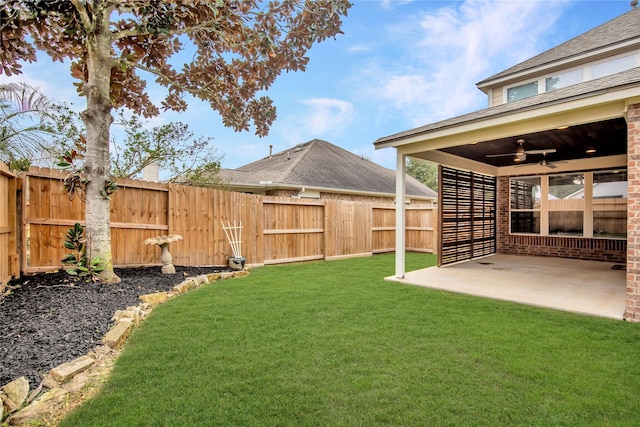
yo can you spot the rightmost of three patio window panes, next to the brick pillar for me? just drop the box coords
[593,170,627,238]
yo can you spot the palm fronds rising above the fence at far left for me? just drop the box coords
[0,83,50,169]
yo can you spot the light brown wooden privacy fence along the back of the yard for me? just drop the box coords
[8,168,436,273]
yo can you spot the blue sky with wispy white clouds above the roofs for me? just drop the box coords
[0,0,631,172]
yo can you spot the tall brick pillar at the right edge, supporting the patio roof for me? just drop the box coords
[624,104,640,322]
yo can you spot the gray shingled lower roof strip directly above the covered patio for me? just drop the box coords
[374,67,640,145]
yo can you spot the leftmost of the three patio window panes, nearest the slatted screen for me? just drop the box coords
[510,177,541,234]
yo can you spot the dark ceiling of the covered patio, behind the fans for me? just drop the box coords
[439,117,627,167]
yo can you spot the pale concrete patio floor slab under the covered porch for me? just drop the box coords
[387,255,626,320]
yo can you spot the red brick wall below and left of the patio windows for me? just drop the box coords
[497,177,624,264]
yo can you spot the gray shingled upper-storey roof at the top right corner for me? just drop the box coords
[477,8,640,86]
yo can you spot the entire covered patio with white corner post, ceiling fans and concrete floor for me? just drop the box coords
[375,75,640,321]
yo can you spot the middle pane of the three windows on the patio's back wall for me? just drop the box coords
[547,174,584,236]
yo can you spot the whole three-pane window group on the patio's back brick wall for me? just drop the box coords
[509,169,627,239]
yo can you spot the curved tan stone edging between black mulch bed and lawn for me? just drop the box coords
[0,269,249,425]
